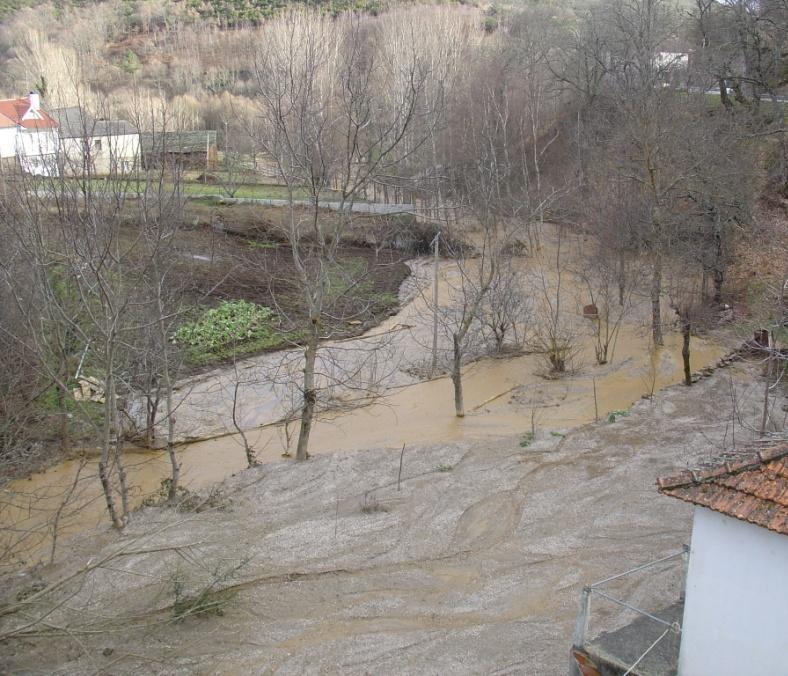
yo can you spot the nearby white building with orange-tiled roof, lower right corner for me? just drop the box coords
[658,444,788,676]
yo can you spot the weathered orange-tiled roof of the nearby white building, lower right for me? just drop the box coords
[657,444,788,535]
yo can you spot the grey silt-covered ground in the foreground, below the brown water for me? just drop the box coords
[0,356,785,675]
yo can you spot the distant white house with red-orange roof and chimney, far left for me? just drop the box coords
[0,92,59,176]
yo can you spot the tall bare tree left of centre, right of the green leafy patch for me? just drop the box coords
[255,11,428,461]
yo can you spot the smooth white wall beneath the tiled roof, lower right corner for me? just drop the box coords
[679,507,788,676]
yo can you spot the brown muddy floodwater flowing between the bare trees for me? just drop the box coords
[0,230,724,569]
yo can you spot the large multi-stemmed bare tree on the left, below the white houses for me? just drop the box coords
[3,88,189,528]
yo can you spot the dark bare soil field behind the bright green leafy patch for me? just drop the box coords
[167,204,416,372]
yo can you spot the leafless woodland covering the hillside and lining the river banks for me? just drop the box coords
[0,0,788,540]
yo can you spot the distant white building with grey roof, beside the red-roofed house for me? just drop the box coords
[52,106,140,175]
